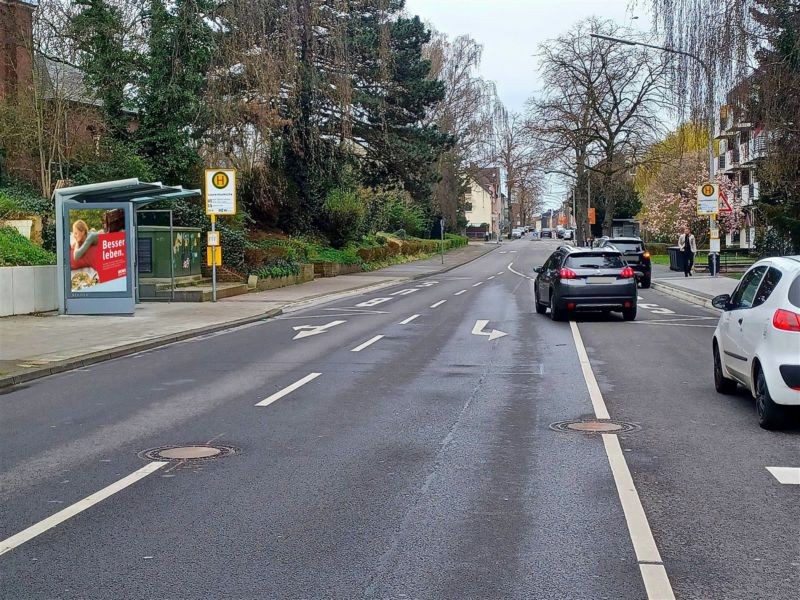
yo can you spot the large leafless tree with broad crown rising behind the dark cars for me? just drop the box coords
[530,18,669,237]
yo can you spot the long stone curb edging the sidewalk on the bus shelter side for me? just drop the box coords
[0,248,494,389]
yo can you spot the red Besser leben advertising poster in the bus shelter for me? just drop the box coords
[69,208,128,293]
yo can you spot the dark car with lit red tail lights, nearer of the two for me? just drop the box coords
[534,246,637,321]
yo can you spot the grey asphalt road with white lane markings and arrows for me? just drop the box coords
[0,240,800,600]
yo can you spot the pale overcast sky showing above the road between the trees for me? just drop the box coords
[406,0,651,206]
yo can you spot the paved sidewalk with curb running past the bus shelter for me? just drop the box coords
[0,243,496,388]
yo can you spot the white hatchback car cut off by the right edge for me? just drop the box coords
[712,256,800,429]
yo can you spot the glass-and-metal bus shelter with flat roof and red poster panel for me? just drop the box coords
[55,179,200,315]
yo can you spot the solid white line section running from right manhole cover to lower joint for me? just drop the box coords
[603,433,661,563]
